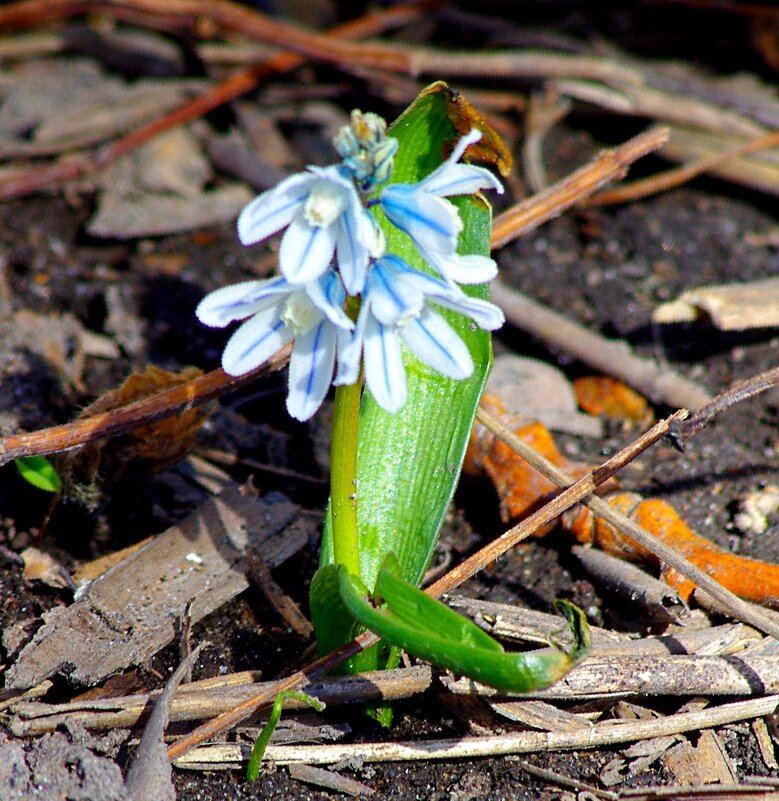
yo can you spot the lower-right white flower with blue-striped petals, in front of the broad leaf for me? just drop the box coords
[334,254,503,412]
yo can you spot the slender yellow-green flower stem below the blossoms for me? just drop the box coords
[330,381,361,576]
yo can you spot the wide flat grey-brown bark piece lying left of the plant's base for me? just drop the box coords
[6,487,306,689]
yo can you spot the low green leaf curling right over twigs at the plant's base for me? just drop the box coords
[335,554,591,692]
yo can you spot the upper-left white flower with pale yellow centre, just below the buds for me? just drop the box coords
[238,166,377,295]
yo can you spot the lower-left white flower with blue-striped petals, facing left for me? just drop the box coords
[196,270,354,420]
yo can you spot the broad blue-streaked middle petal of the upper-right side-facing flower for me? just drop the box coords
[379,184,463,253]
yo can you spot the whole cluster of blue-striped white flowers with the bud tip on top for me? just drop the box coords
[196,111,503,420]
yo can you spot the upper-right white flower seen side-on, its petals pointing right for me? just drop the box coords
[378,129,503,284]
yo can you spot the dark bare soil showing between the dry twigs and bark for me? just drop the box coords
[0,4,779,801]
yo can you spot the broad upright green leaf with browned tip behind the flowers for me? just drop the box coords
[320,84,492,587]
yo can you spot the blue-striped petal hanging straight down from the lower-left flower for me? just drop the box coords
[287,320,336,420]
